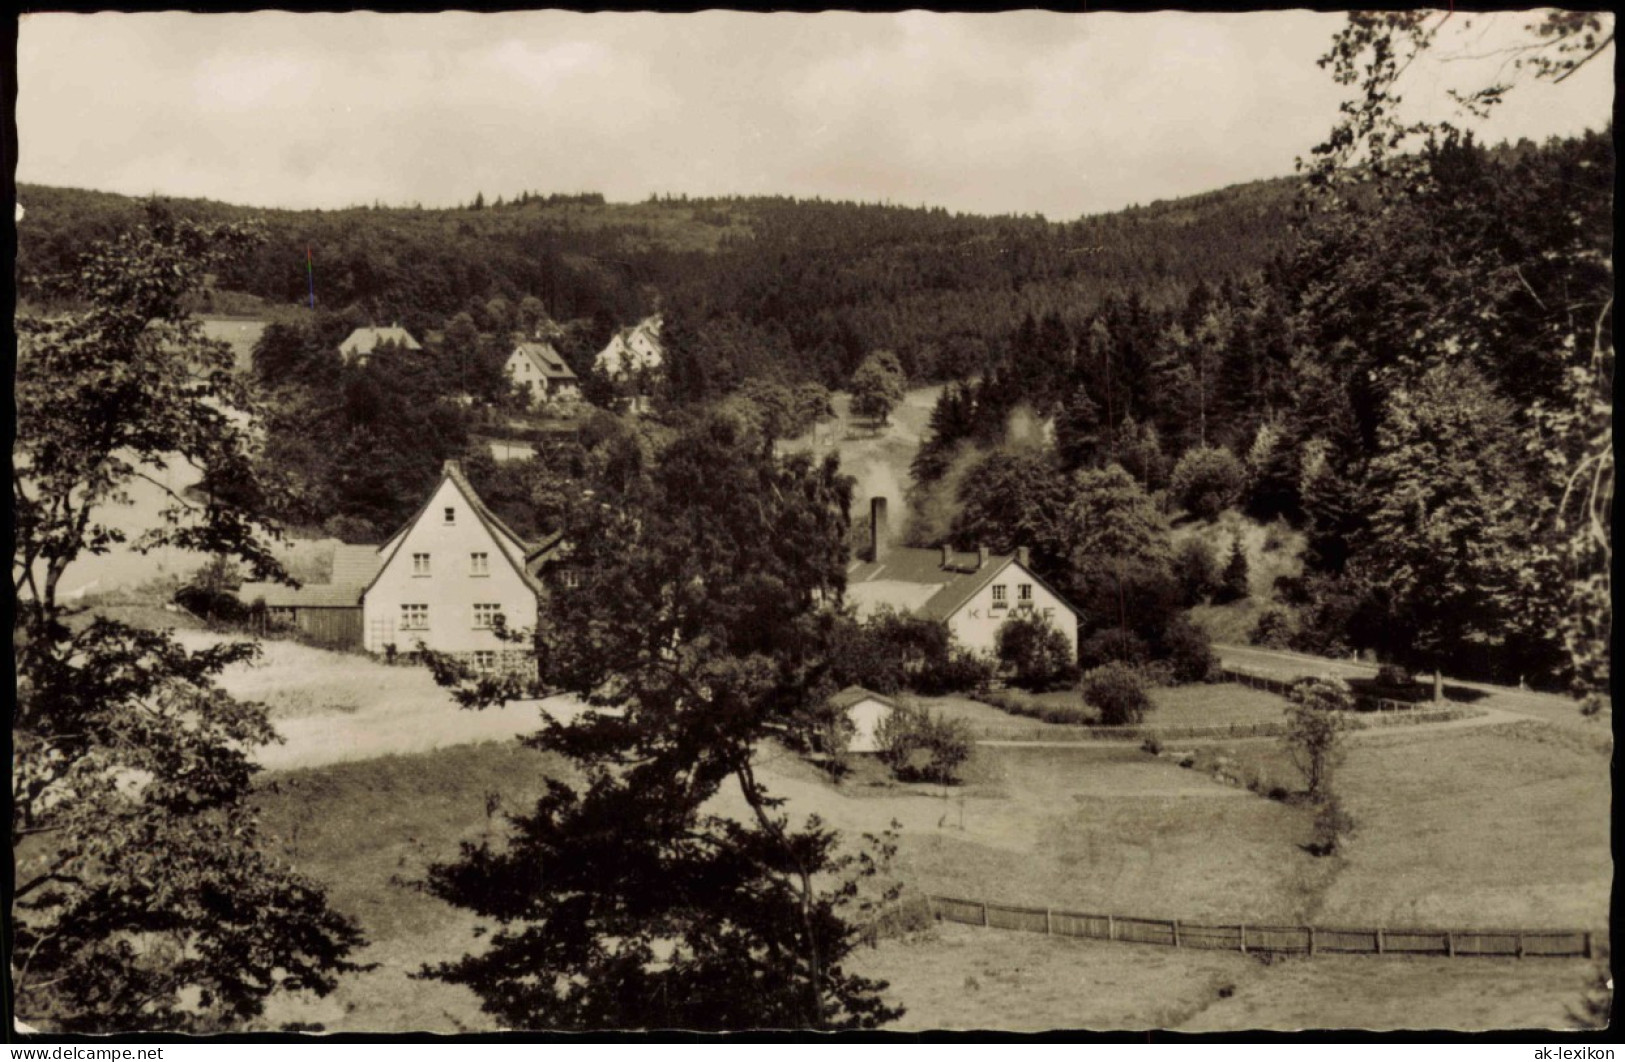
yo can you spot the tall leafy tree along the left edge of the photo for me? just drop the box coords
[8,206,359,1033]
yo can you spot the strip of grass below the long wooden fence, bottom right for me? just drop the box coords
[852,924,1591,1033]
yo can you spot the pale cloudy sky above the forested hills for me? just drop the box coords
[16,11,1614,219]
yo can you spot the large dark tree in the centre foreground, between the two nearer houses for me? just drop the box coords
[426,412,899,1030]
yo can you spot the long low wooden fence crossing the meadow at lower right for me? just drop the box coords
[925,895,1593,958]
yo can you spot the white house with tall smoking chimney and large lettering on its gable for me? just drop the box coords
[847,497,1079,659]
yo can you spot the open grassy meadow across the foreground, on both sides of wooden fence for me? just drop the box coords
[243,646,1612,1031]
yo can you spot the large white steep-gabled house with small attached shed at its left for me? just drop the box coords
[361,461,541,671]
